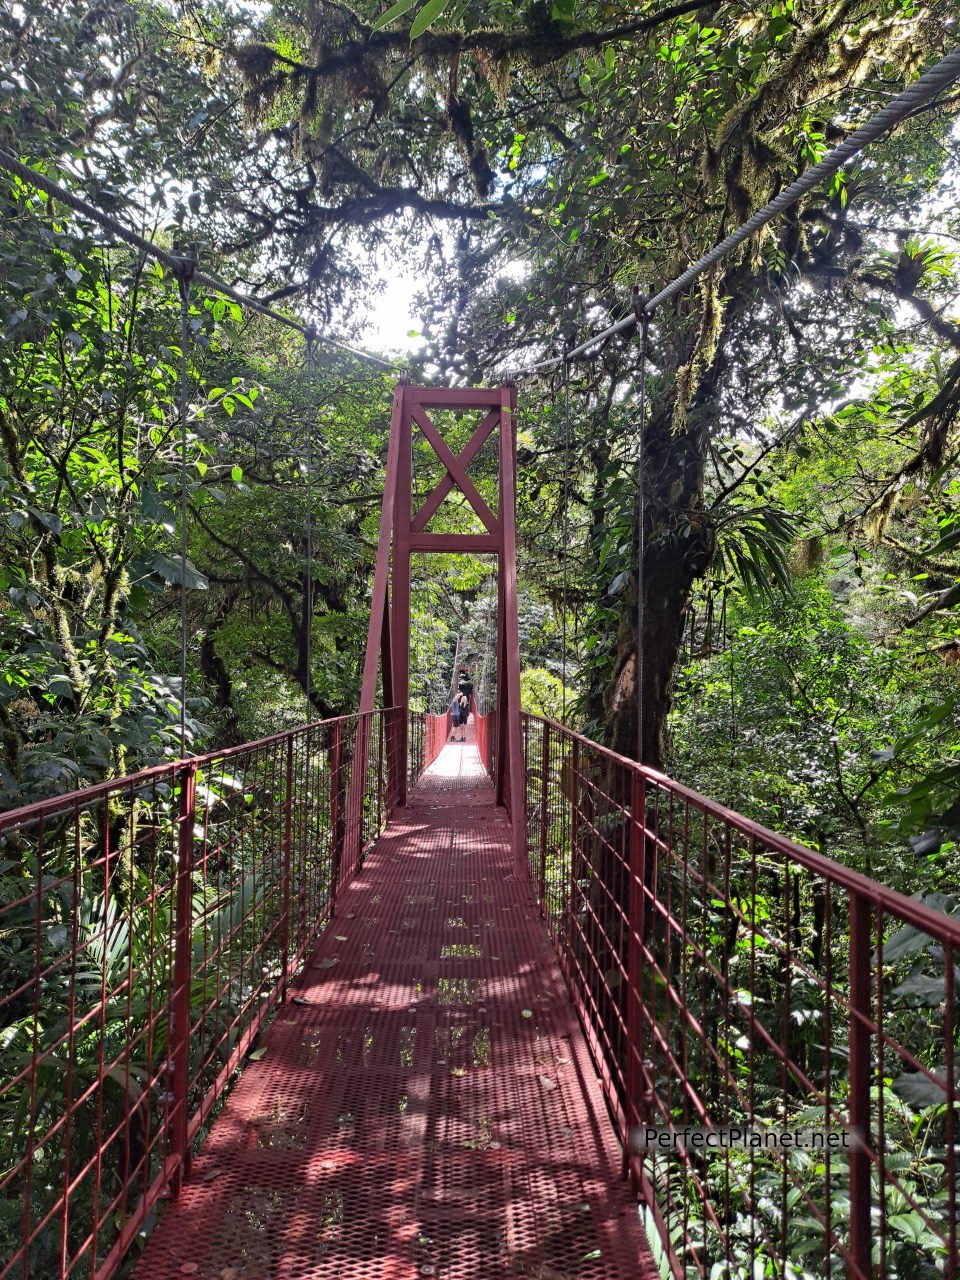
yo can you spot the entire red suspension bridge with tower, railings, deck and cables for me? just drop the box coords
[0,51,960,1280]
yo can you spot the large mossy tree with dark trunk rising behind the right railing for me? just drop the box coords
[179,0,954,763]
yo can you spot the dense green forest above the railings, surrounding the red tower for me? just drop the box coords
[0,0,960,888]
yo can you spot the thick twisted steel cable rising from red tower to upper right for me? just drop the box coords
[513,47,960,378]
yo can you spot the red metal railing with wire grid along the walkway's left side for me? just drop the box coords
[0,709,406,1280]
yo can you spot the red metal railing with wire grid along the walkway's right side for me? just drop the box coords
[524,716,960,1280]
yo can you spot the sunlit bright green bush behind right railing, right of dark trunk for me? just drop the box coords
[672,573,942,891]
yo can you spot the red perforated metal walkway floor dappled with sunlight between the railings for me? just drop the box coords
[134,724,657,1280]
